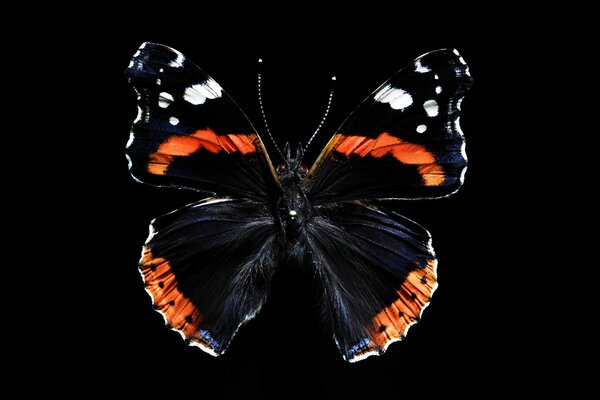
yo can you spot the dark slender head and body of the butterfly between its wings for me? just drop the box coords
[277,143,310,245]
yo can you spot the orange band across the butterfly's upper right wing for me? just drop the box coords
[335,132,445,186]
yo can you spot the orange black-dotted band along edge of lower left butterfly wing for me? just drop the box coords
[140,247,202,340]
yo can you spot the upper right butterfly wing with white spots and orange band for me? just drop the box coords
[304,49,472,204]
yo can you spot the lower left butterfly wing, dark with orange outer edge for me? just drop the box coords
[139,198,277,356]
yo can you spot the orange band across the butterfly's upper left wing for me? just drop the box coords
[148,128,257,175]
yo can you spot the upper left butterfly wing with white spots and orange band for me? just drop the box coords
[126,43,279,199]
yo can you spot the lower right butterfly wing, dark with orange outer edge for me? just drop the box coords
[307,202,437,362]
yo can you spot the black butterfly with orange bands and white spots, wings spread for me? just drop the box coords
[126,43,472,362]
